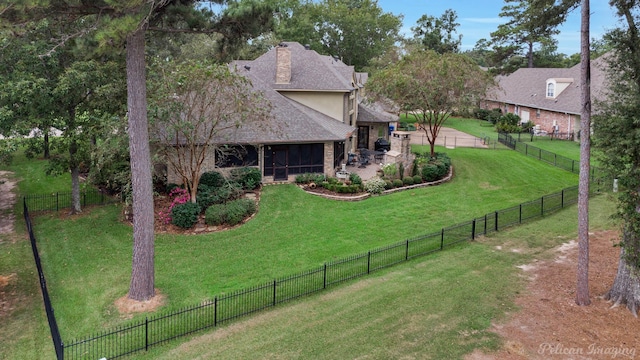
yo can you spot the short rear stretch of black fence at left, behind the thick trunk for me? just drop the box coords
[22,189,120,212]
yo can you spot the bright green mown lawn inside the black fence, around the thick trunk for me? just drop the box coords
[20,148,577,338]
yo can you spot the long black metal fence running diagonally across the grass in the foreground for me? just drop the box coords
[33,186,578,359]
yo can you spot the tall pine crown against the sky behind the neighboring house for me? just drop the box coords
[491,0,577,68]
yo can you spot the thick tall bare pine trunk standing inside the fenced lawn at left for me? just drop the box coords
[126,28,155,301]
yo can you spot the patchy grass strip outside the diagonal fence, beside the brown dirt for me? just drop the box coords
[137,196,615,360]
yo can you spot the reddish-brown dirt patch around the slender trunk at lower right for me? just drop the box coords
[466,231,640,360]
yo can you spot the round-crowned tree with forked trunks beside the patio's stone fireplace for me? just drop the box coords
[367,50,493,156]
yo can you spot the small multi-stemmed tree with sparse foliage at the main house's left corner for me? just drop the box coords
[151,62,270,202]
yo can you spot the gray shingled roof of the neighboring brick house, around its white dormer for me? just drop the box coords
[487,56,606,114]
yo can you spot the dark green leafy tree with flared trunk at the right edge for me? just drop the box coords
[593,0,640,316]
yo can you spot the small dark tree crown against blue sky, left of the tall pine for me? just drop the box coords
[411,9,462,54]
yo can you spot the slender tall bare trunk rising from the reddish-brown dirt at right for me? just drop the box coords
[576,0,591,305]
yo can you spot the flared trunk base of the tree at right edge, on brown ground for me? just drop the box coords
[604,246,640,317]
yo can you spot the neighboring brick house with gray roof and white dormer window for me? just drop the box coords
[482,55,606,140]
